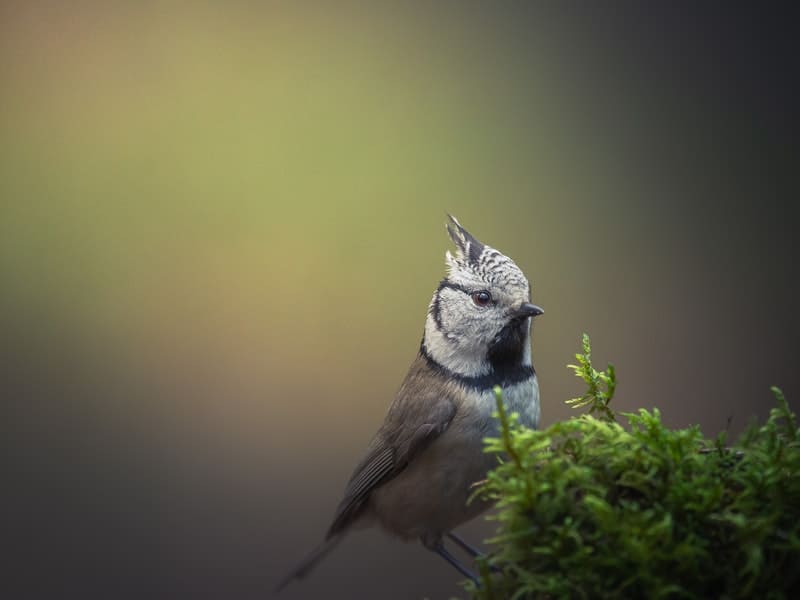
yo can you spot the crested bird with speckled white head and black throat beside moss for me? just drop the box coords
[277,216,543,590]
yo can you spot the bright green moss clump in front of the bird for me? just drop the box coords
[468,336,800,599]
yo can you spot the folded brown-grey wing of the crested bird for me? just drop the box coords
[327,390,456,538]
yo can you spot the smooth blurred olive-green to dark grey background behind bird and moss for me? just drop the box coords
[0,1,800,599]
